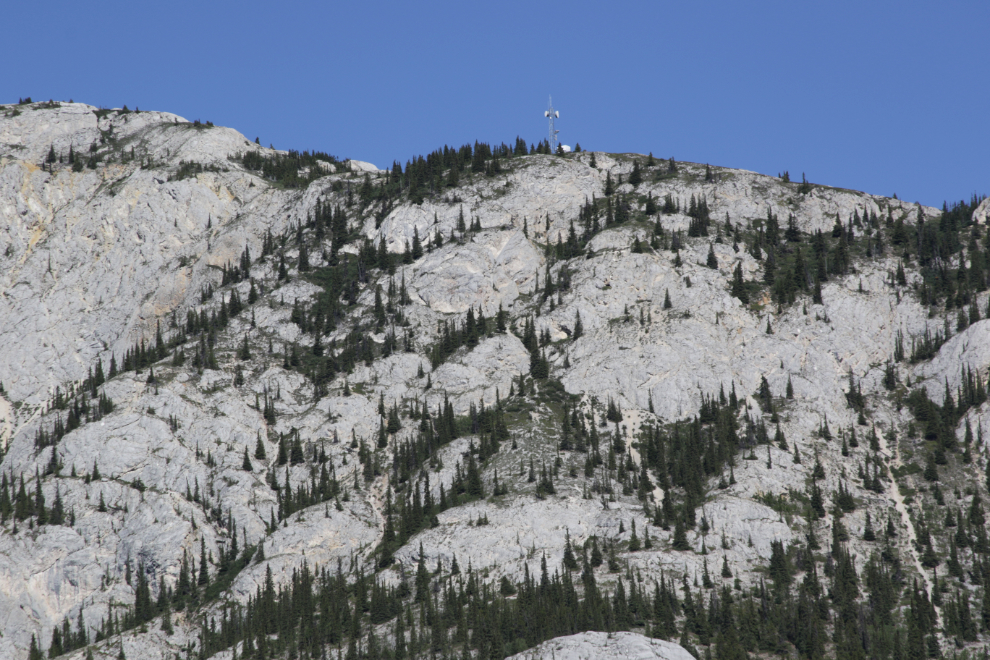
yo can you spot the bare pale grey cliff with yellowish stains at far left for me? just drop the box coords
[0,104,286,403]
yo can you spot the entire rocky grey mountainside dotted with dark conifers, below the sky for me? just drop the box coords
[0,102,990,660]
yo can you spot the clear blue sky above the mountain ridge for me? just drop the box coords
[0,0,990,205]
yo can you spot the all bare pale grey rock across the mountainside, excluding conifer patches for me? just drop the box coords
[0,99,990,660]
